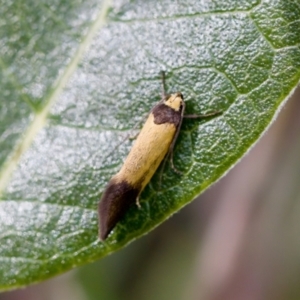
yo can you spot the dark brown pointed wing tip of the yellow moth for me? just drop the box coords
[98,179,140,241]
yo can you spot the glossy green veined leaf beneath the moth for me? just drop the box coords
[0,0,300,290]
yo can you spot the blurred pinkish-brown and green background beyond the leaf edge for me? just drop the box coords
[0,89,300,300]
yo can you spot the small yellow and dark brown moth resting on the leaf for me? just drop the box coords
[98,72,219,240]
